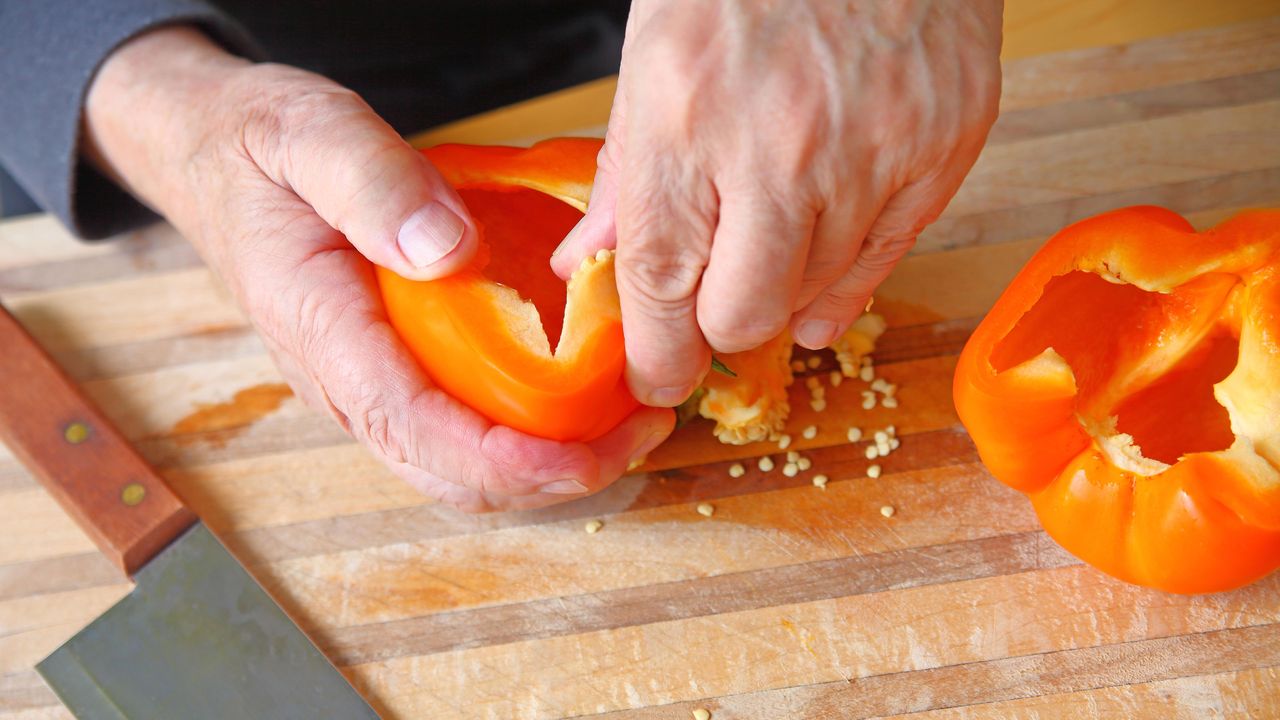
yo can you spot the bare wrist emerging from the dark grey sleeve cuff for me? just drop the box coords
[81,27,248,220]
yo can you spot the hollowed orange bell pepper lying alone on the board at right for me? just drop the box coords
[954,208,1280,593]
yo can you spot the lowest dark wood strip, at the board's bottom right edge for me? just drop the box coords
[579,624,1280,720]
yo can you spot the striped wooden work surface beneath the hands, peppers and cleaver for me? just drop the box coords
[0,0,1280,720]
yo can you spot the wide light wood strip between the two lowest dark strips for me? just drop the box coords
[351,565,1280,720]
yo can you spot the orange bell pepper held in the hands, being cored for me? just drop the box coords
[378,133,639,441]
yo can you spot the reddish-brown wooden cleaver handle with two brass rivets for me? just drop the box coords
[0,307,196,577]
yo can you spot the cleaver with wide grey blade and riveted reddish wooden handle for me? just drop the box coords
[0,307,378,720]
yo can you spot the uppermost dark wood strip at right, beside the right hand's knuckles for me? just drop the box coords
[987,69,1280,145]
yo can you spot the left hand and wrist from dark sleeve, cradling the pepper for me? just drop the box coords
[84,28,672,511]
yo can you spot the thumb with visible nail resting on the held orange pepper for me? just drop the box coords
[252,81,477,279]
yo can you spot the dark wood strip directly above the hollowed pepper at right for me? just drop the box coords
[911,167,1280,255]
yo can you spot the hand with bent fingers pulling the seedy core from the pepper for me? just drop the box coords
[552,0,1002,406]
